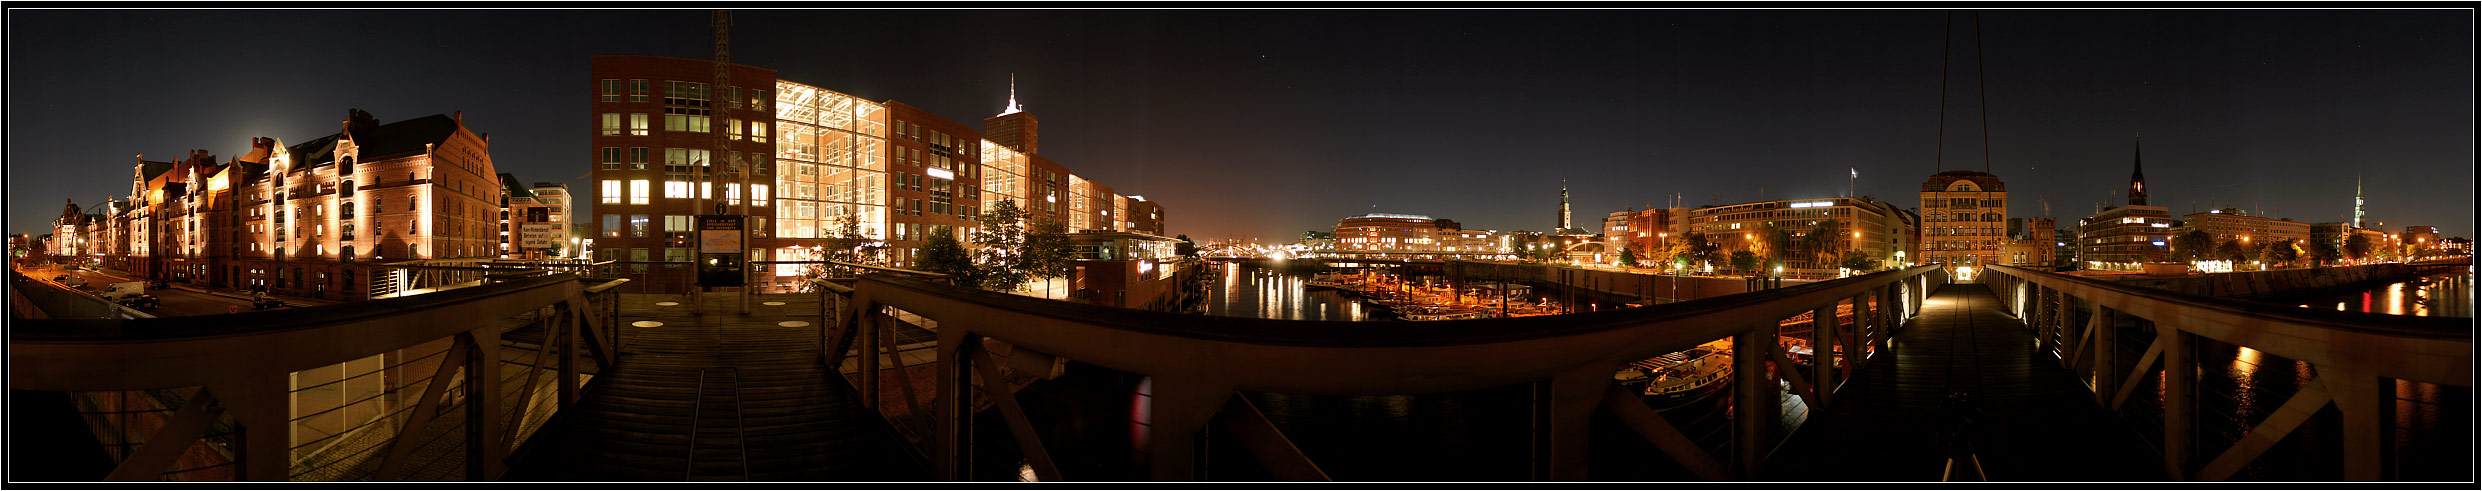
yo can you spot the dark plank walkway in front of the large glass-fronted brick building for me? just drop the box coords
[506,293,928,481]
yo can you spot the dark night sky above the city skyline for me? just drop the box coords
[7,10,2475,241]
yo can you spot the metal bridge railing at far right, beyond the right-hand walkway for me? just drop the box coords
[1981,265,2475,481]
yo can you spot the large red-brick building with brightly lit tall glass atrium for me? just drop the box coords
[578,55,1164,293]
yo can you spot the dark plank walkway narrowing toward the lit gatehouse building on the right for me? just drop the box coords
[1762,283,2167,481]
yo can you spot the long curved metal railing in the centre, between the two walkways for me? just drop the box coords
[822,265,1946,481]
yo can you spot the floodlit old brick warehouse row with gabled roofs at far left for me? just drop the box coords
[84,109,501,300]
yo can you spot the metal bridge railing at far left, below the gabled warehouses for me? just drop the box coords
[10,275,621,481]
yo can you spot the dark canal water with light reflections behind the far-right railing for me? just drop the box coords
[2120,273,2475,481]
